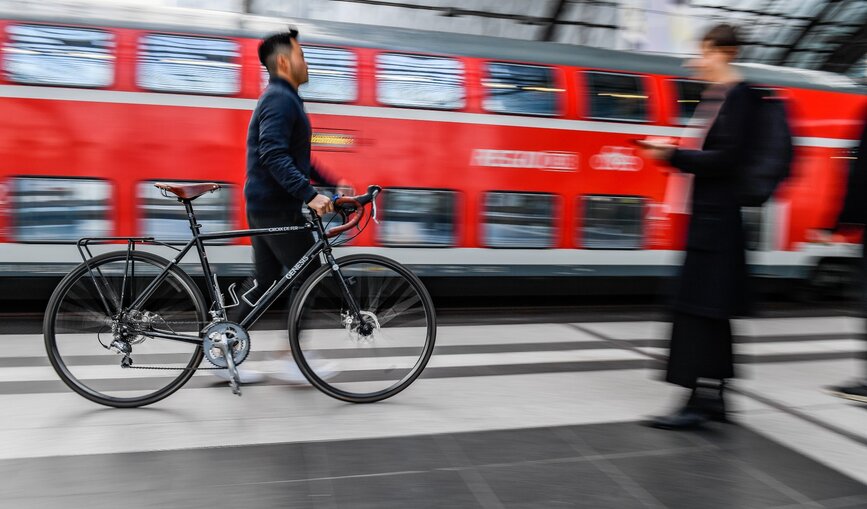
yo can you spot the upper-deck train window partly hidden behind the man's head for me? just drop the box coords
[262,45,358,103]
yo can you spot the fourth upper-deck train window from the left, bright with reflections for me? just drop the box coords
[376,53,466,110]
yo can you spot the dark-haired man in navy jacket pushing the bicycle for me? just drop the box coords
[216,30,335,383]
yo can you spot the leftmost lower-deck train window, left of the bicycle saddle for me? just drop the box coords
[9,177,113,242]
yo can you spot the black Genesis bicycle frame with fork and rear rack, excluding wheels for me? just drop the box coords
[78,200,361,344]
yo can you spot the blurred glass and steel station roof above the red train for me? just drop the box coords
[0,0,867,79]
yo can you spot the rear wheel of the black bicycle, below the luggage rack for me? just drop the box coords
[43,251,207,408]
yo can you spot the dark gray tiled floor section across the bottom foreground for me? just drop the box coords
[0,423,867,509]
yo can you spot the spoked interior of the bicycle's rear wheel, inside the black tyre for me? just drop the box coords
[53,254,202,404]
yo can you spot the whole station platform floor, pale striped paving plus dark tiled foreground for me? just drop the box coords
[0,316,867,509]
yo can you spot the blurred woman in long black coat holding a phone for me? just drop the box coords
[639,25,760,429]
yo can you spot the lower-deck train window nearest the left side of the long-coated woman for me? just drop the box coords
[579,195,645,249]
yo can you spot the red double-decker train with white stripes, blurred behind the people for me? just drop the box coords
[0,11,867,296]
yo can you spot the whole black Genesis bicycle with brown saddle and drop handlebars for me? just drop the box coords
[43,183,436,408]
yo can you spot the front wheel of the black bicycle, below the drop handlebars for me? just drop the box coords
[289,255,436,403]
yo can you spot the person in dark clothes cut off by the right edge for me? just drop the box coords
[811,109,867,403]
